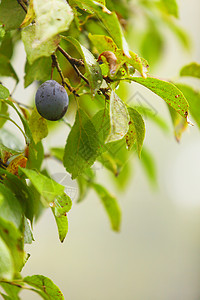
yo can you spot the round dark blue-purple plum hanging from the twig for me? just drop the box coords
[35,80,69,121]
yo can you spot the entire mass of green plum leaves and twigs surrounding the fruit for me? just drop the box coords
[0,0,200,299]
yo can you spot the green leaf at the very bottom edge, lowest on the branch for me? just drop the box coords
[23,275,64,300]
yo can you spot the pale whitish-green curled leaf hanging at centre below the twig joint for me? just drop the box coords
[106,91,130,143]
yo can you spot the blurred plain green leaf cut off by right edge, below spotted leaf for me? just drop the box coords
[176,83,200,128]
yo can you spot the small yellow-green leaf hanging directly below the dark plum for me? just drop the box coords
[29,108,48,144]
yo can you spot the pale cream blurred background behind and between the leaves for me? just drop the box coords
[2,0,200,300]
